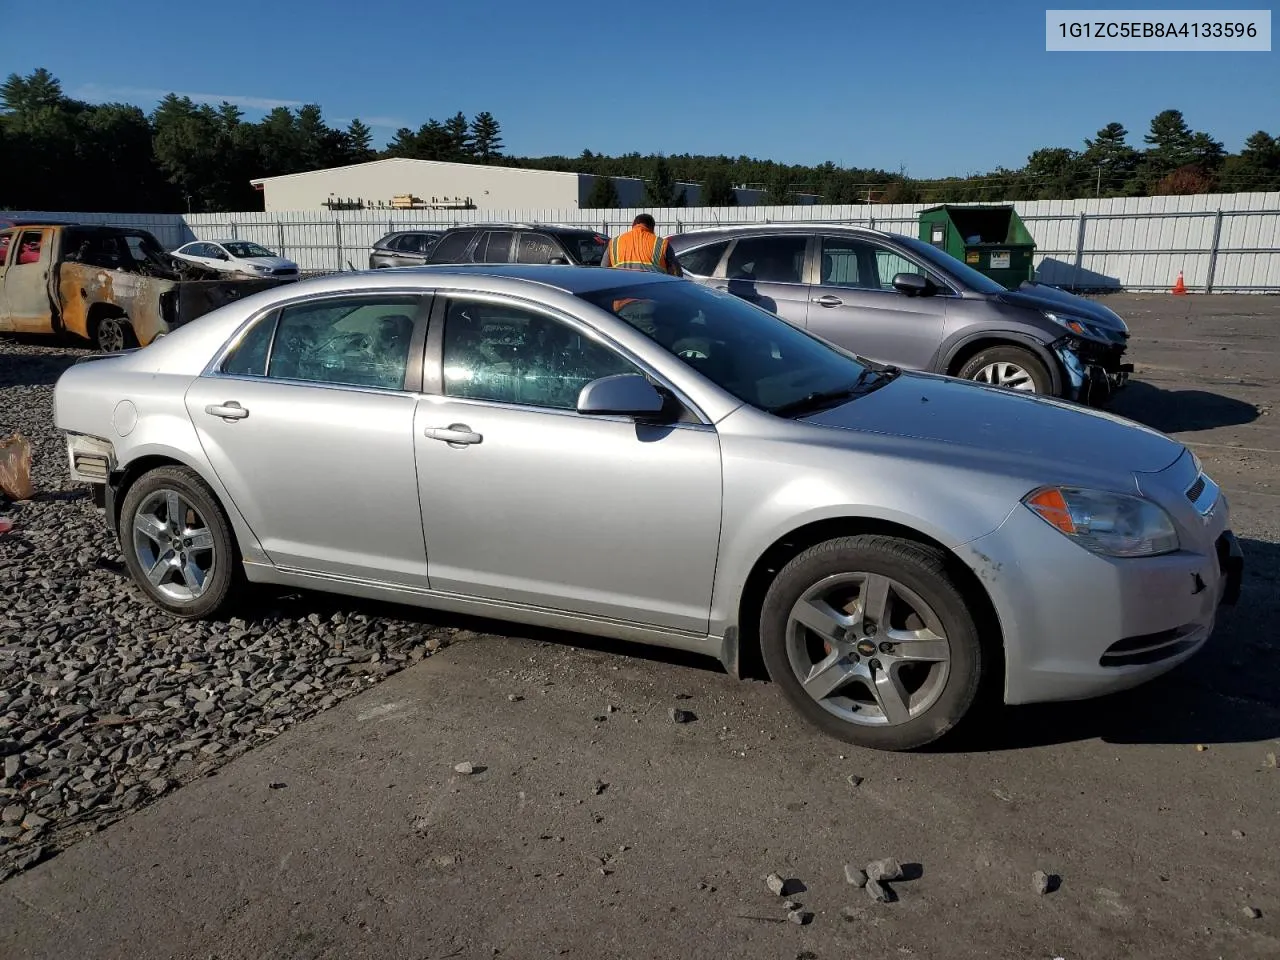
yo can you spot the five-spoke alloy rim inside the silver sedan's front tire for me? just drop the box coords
[786,572,951,726]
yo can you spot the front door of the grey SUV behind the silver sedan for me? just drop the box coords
[808,234,946,370]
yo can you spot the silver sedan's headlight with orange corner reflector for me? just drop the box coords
[1023,486,1178,557]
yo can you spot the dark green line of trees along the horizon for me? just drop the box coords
[0,69,1280,212]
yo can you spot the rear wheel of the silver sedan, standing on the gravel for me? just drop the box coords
[119,467,239,620]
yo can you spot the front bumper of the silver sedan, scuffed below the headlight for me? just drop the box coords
[957,488,1244,704]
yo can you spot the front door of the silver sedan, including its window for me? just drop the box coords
[413,294,721,635]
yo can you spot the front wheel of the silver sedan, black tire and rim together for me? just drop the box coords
[760,536,993,750]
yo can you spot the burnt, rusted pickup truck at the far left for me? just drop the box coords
[0,223,293,352]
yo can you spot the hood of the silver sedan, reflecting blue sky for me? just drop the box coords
[805,374,1184,475]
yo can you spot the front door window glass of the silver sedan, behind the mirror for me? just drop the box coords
[443,298,639,410]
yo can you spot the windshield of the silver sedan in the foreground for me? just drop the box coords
[579,282,867,412]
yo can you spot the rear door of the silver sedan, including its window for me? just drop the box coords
[186,292,428,589]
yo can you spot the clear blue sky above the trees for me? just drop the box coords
[0,0,1280,177]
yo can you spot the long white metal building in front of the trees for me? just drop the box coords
[251,157,815,212]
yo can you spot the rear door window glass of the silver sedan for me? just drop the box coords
[254,294,419,390]
